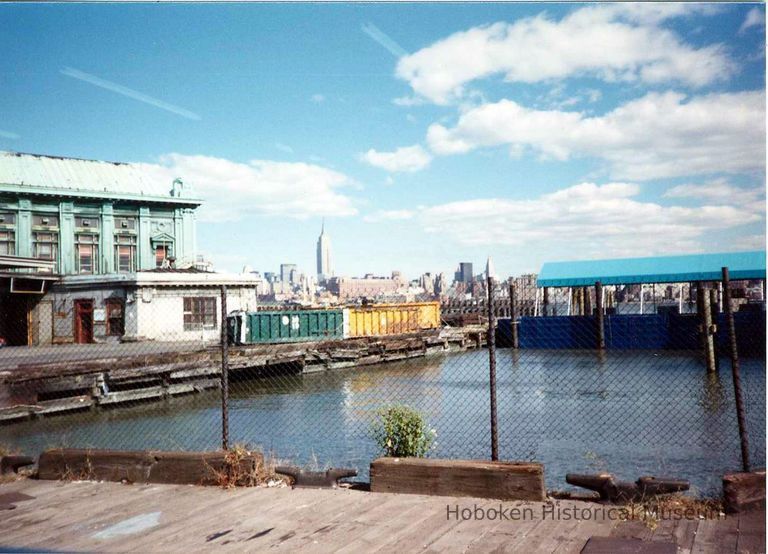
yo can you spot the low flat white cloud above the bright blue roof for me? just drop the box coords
[417,183,764,256]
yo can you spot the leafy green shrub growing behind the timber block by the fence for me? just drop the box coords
[371,406,436,458]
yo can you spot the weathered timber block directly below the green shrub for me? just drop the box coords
[371,458,546,500]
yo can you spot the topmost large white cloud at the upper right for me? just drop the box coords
[396,4,736,105]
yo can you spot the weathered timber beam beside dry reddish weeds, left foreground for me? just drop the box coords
[38,448,264,485]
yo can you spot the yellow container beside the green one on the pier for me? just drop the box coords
[345,302,440,337]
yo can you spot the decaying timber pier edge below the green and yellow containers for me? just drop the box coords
[0,326,485,424]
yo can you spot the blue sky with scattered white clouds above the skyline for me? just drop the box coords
[0,3,766,278]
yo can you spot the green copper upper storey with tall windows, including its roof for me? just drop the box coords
[0,152,201,275]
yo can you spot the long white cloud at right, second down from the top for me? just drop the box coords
[427,91,765,180]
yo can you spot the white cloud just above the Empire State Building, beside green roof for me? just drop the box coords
[138,154,357,222]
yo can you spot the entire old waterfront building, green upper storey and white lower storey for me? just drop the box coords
[0,152,259,346]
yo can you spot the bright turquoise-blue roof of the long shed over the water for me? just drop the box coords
[536,252,765,287]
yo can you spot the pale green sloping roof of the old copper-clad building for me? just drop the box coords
[0,152,201,206]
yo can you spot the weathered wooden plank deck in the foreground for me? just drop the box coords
[0,480,765,554]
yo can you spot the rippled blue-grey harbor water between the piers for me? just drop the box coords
[0,350,765,494]
